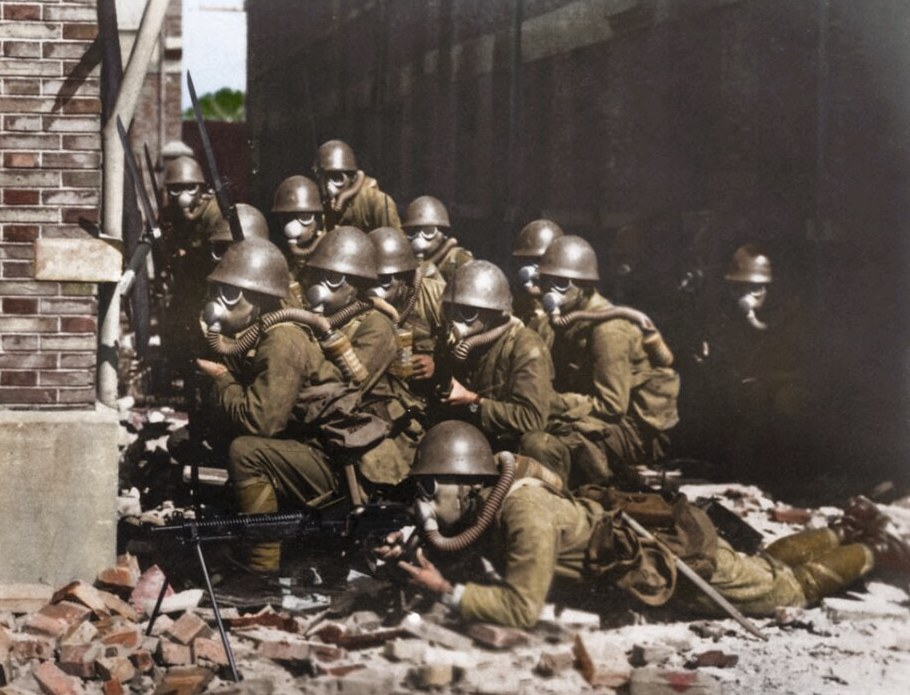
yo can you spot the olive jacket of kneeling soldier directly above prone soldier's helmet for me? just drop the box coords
[438,320,556,450]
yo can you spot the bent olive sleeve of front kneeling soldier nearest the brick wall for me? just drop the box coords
[214,326,306,437]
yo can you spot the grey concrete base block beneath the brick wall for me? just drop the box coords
[0,406,119,586]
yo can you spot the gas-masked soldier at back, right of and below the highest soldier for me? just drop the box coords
[401,195,474,282]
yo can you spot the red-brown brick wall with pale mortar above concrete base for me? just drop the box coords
[0,0,101,408]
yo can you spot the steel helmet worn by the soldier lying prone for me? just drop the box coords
[411,420,499,477]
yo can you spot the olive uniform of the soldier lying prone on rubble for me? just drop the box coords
[456,479,873,628]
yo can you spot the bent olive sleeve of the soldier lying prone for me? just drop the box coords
[459,497,558,628]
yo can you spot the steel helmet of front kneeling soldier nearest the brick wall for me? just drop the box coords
[208,239,289,298]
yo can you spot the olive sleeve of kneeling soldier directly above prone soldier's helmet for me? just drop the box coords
[480,329,554,434]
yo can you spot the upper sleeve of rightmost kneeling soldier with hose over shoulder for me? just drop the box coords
[589,320,634,419]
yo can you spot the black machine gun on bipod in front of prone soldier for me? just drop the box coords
[145,502,414,683]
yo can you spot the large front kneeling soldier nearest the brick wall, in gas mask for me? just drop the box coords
[197,237,416,575]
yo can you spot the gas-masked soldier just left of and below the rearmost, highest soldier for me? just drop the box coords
[272,176,325,305]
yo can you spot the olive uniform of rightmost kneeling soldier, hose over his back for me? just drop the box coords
[522,292,679,488]
